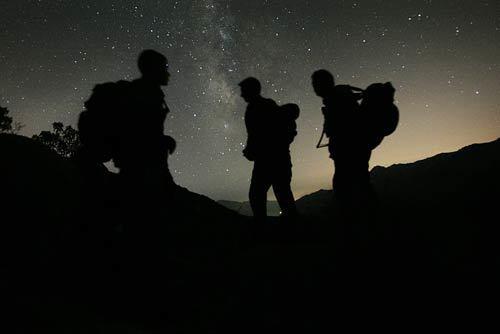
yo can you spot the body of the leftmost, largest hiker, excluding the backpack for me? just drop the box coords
[114,50,176,192]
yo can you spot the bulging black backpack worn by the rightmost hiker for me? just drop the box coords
[360,82,399,150]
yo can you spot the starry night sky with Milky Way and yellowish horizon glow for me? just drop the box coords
[0,0,500,200]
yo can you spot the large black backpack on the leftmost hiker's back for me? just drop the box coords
[78,80,131,162]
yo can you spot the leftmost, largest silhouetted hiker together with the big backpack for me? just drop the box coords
[78,50,175,196]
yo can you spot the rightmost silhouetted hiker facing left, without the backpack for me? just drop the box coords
[312,70,371,208]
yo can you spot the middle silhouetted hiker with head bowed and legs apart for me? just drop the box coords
[239,77,298,219]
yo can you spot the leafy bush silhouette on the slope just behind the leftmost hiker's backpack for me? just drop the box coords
[32,122,80,158]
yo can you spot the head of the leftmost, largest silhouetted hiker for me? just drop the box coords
[137,50,170,86]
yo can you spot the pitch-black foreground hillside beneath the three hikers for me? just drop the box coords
[0,135,500,333]
